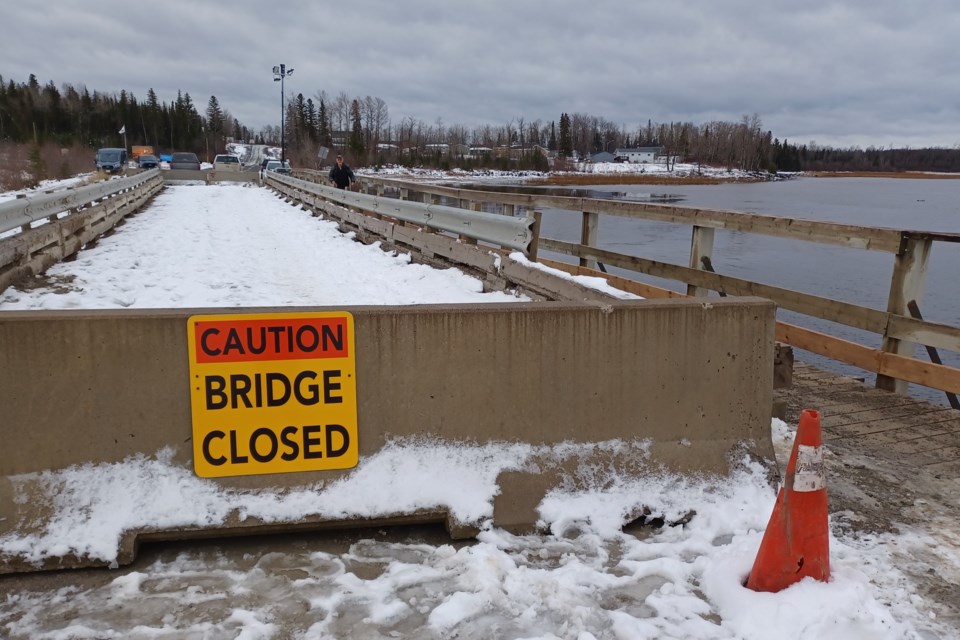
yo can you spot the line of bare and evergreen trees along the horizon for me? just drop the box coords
[0,74,960,178]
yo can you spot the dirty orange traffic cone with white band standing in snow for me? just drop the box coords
[747,409,830,592]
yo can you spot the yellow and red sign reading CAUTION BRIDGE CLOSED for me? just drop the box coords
[187,312,359,478]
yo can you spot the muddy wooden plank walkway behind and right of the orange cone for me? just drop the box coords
[774,362,960,630]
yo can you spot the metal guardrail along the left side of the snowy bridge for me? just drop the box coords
[0,169,160,233]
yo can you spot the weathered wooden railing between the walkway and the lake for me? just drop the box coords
[344,176,960,402]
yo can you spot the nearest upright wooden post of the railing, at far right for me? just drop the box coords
[877,233,933,395]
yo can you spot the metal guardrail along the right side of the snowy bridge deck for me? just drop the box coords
[266,173,536,252]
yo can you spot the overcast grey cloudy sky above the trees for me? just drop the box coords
[7,0,960,147]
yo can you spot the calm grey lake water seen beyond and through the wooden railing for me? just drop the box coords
[474,178,960,404]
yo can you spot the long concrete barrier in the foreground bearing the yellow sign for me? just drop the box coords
[0,298,774,572]
